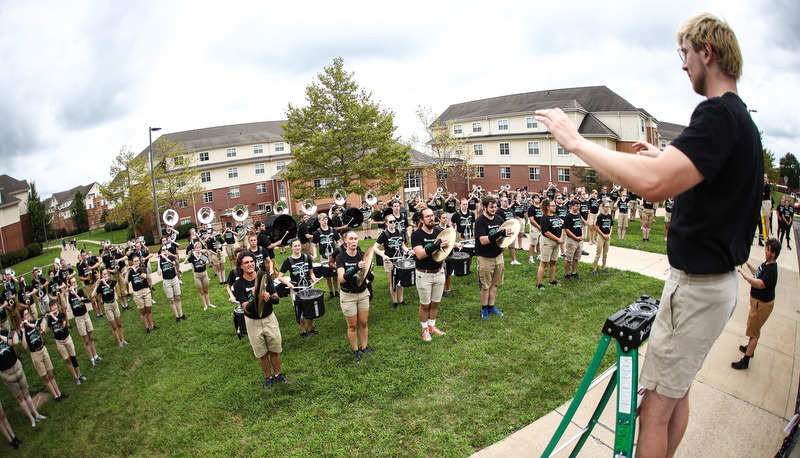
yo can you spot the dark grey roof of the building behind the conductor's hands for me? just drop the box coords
[439,86,639,122]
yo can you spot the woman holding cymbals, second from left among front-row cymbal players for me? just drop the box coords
[336,231,376,363]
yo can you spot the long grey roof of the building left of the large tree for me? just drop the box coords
[139,120,286,156]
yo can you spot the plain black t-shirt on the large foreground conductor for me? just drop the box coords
[667,92,764,274]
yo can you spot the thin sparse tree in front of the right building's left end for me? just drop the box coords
[411,106,475,193]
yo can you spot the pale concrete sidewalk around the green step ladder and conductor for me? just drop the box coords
[473,228,800,458]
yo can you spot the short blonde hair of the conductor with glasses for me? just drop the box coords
[678,13,742,81]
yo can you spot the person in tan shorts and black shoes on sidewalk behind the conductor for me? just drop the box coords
[731,238,781,370]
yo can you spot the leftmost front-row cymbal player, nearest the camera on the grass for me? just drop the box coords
[233,250,288,390]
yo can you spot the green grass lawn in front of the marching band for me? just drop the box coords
[0,242,663,457]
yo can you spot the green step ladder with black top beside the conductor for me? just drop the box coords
[542,295,659,458]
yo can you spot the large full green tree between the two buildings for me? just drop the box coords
[282,57,410,199]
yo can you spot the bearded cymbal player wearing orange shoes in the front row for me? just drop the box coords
[411,208,449,342]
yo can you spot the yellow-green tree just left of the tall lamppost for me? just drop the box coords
[100,146,153,236]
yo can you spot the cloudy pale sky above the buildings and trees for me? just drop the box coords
[0,0,800,197]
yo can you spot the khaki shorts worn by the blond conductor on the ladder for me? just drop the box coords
[639,268,739,399]
